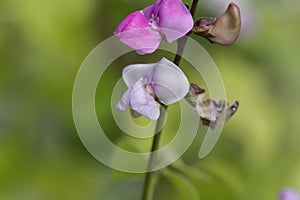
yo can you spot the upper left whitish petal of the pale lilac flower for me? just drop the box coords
[122,63,157,87]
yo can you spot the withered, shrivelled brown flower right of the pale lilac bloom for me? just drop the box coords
[185,83,239,129]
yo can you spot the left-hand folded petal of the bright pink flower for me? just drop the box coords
[114,11,162,54]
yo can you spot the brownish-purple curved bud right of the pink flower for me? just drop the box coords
[192,3,241,45]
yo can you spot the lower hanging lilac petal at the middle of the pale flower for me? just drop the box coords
[130,80,160,120]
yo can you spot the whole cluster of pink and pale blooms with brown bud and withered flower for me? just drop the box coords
[114,0,241,128]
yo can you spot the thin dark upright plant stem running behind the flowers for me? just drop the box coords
[142,0,199,200]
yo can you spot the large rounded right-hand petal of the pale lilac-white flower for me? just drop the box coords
[151,58,190,105]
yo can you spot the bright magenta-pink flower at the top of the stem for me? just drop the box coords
[114,0,194,54]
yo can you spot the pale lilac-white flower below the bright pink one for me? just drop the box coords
[117,58,189,120]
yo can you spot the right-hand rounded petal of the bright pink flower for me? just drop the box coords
[154,0,194,42]
